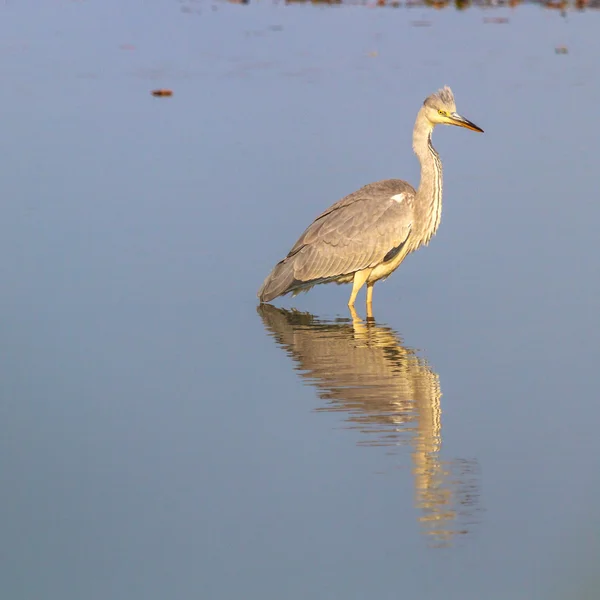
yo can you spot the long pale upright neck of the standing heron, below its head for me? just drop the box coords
[413,109,442,244]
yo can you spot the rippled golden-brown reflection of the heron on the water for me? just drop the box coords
[257,304,479,545]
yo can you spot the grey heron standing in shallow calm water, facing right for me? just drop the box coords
[258,87,483,314]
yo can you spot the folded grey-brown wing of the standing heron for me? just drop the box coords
[283,180,415,282]
